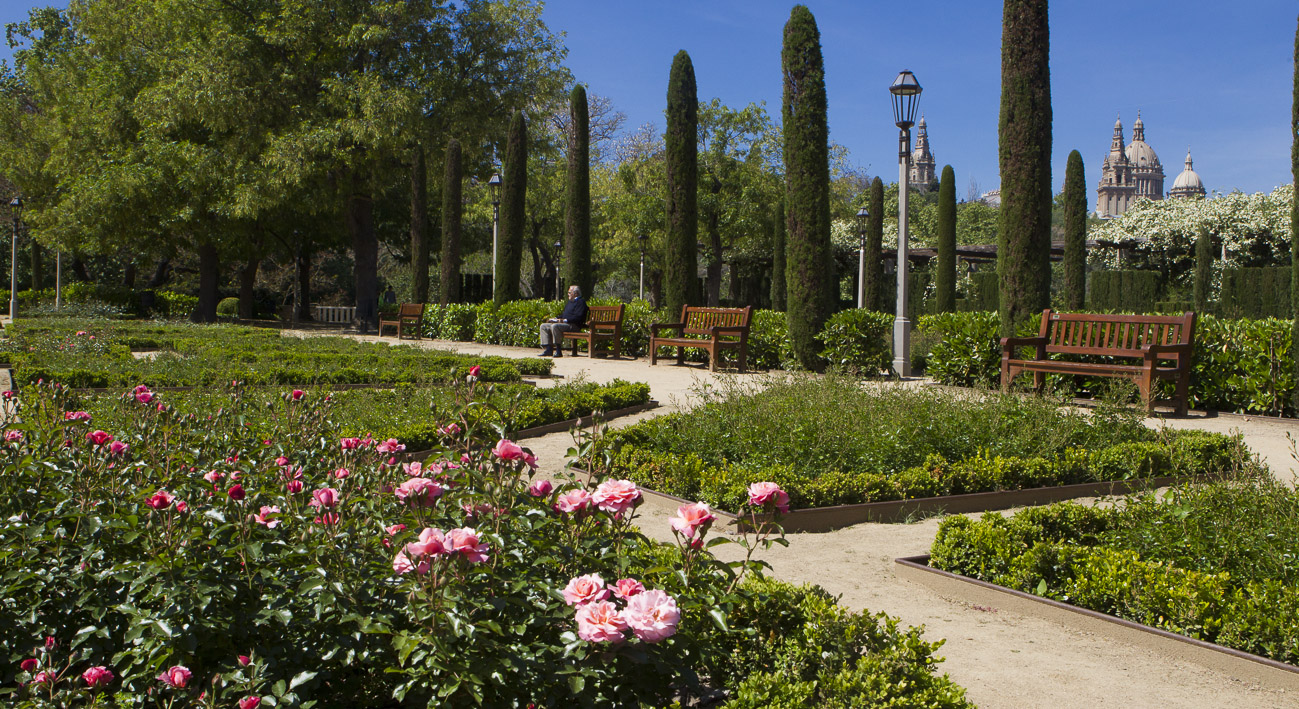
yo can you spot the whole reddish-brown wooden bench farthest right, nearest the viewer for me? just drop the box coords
[1002,309,1195,416]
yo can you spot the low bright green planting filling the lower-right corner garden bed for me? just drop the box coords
[930,482,1299,665]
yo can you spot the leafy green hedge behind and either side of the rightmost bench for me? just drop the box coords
[920,313,1296,416]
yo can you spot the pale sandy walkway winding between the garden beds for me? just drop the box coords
[289,331,1299,709]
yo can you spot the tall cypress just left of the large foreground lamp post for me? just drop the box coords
[781,5,839,370]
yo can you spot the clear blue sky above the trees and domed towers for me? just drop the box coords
[0,0,1299,210]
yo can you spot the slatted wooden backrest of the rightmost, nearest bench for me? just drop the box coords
[1039,309,1195,360]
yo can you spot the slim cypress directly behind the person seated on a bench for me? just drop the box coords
[557,84,595,297]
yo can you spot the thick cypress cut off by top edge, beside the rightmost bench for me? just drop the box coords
[996,0,1051,336]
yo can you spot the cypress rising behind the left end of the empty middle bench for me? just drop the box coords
[662,49,699,317]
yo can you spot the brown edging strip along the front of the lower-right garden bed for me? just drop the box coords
[894,554,1299,692]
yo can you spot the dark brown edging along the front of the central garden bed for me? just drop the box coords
[628,477,1192,532]
